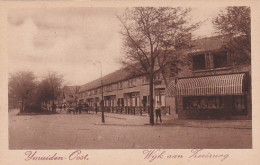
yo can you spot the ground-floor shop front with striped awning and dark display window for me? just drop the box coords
[168,73,251,119]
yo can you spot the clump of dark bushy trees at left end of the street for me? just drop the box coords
[8,72,62,113]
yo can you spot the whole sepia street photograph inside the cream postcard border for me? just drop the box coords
[6,6,253,150]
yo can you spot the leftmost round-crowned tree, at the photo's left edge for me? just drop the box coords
[8,71,37,113]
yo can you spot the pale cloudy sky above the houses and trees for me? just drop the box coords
[7,8,223,85]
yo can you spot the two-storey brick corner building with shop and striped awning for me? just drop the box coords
[167,36,252,119]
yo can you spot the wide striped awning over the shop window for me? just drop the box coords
[166,73,245,96]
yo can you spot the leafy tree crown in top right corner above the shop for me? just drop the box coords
[213,6,251,65]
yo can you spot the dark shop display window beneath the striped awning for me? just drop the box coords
[183,96,224,110]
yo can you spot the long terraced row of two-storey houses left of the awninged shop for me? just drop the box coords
[78,69,175,114]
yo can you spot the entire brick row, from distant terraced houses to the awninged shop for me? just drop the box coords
[62,36,252,119]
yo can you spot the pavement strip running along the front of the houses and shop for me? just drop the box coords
[94,113,252,129]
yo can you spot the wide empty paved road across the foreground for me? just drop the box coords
[9,109,252,149]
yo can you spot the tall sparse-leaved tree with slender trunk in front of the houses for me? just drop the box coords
[118,7,199,125]
